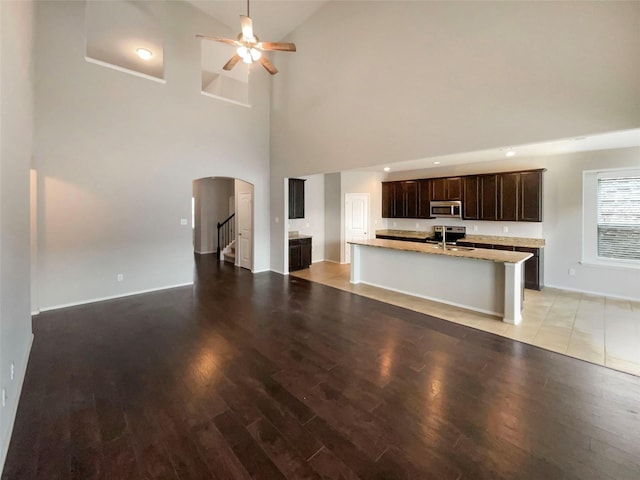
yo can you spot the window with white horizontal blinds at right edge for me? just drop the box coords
[597,176,640,261]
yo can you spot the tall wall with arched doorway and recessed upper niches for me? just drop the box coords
[34,2,270,308]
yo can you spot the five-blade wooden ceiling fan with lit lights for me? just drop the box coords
[196,0,296,75]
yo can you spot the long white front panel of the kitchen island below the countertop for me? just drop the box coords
[351,245,505,317]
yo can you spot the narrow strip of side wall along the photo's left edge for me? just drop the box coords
[0,1,34,466]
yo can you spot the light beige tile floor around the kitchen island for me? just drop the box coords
[291,262,640,376]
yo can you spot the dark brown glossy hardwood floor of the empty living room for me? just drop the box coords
[2,257,640,480]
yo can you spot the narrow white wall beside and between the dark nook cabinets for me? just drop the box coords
[287,175,325,262]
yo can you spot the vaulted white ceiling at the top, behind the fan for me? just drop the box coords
[185,0,327,42]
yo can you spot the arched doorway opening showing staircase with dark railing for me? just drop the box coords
[192,177,254,271]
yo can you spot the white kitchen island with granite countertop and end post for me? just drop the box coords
[349,239,531,324]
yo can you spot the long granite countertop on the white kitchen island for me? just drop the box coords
[349,238,532,263]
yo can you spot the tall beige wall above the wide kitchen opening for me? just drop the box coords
[271,1,640,274]
